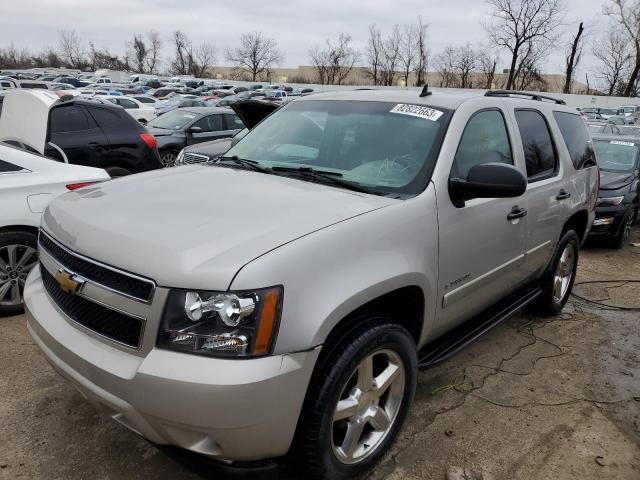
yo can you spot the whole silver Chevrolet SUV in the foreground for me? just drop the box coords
[25,90,598,480]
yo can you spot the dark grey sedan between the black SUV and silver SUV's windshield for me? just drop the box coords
[147,107,244,167]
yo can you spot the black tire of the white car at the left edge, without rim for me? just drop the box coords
[0,230,38,316]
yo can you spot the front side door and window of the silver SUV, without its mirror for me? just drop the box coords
[436,108,527,330]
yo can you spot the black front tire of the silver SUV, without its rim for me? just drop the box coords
[293,317,418,480]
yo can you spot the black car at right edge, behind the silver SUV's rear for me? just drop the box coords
[591,135,640,248]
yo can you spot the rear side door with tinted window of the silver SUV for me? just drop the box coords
[513,109,570,277]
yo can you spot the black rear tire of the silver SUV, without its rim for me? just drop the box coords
[529,230,580,317]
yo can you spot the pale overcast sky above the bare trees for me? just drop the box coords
[0,0,610,79]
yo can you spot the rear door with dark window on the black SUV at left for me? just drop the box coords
[46,105,108,167]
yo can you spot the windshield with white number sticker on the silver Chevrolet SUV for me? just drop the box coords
[227,100,449,194]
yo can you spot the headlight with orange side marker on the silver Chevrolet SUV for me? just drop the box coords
[158,287,282,357]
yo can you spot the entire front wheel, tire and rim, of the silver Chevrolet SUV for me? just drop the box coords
[296,318,418,479]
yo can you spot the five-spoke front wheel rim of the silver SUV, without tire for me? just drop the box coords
[331,349,405,465]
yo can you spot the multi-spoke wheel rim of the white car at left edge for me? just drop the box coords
[0,245,38,307]
